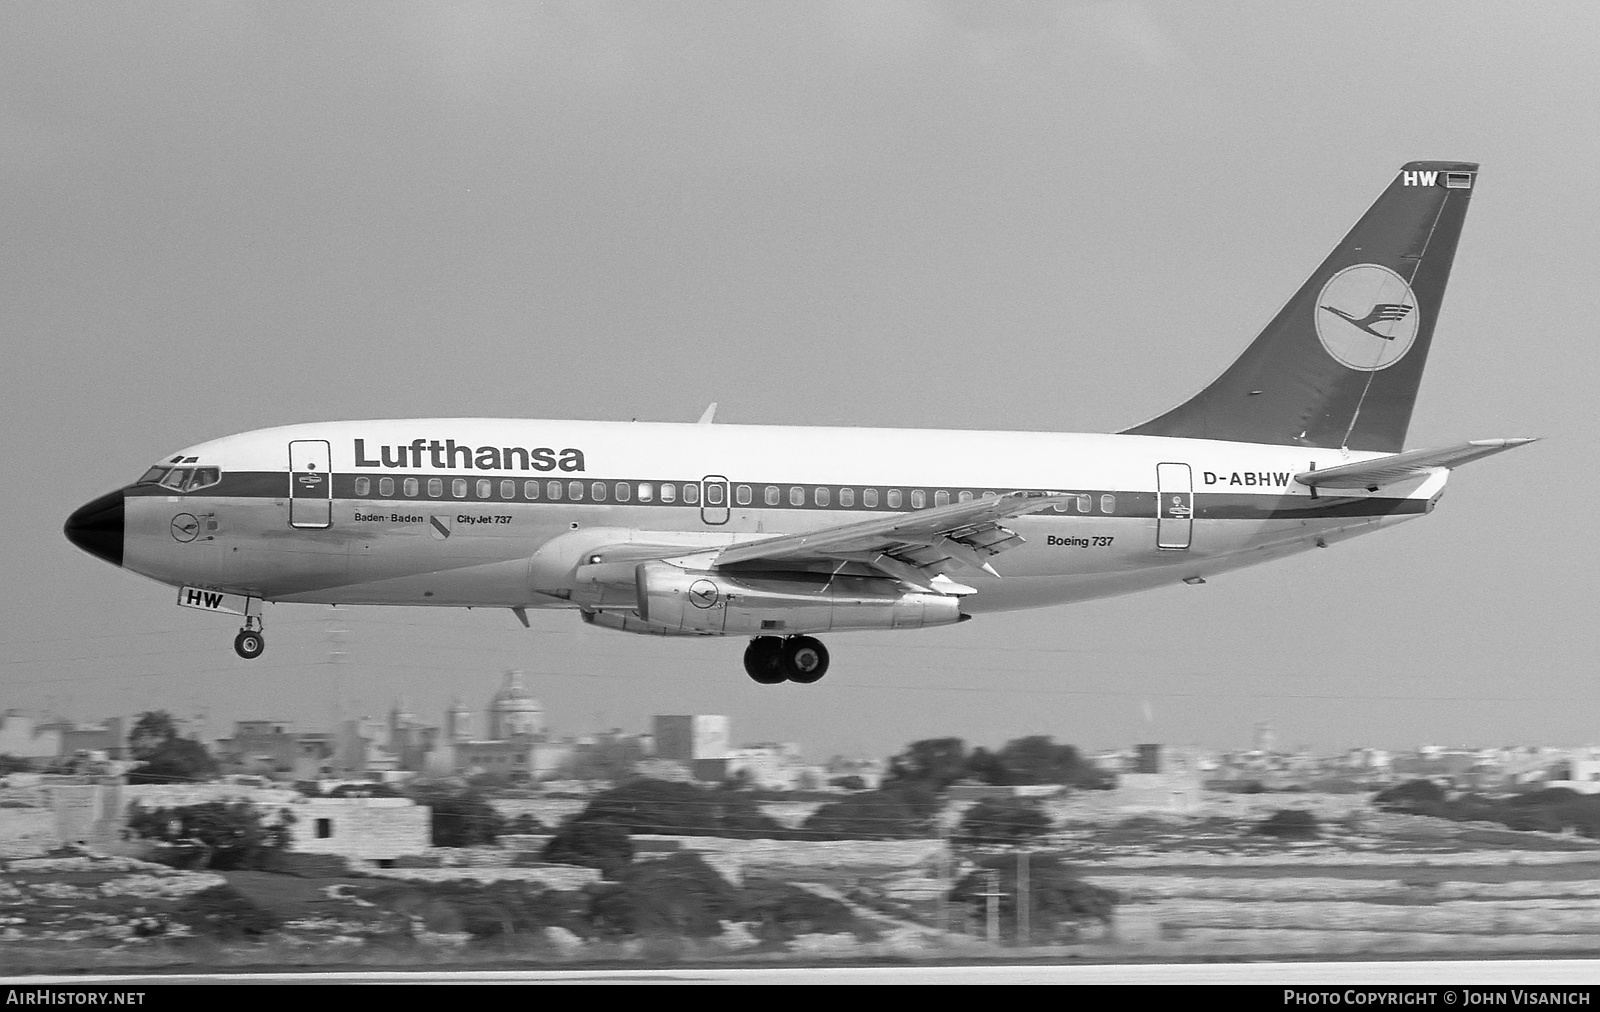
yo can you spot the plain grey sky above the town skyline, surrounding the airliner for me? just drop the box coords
[0,0,1600,757]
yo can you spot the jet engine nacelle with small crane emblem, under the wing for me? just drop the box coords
[634,562,966,636]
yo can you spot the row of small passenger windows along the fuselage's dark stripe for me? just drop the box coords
[355,477,1117,514]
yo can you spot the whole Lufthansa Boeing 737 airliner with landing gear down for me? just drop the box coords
[66,162,1531,684]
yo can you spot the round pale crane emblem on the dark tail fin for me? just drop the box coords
[1314,264,1421,373]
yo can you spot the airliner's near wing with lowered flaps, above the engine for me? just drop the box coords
[715,492,1074,594]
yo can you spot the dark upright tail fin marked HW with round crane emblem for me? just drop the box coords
[1126,162,1478,453]
